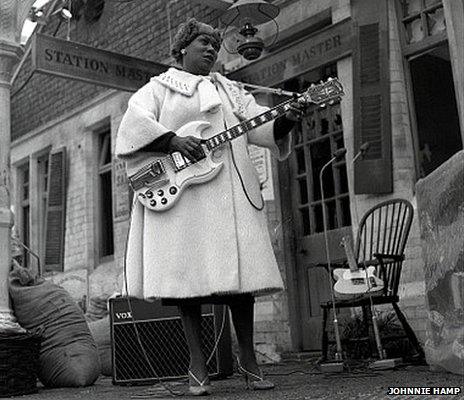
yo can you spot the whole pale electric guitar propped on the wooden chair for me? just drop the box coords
[333,237,383,299]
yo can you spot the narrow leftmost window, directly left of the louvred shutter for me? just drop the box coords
[17,162,31,268]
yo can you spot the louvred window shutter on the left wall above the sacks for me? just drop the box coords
[45,147,66,271]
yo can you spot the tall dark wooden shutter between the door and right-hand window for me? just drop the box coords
[352,0,393,194]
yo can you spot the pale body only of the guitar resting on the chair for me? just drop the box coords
[333,266,383,299]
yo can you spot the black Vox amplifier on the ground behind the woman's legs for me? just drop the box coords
[109,297,233,385]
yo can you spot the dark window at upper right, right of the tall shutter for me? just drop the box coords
[399,0,462,178]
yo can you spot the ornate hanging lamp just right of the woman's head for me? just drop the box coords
[220,0,280,60]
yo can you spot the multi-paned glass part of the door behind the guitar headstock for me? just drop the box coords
[274,64,351,236]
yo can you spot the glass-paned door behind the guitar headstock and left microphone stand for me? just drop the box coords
[284,65,351,350]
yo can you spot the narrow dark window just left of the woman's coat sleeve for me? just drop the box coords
[98,128,114,259]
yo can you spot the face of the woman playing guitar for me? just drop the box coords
[182,34,219,75]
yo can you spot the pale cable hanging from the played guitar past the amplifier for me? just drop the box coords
[119,197,228,398]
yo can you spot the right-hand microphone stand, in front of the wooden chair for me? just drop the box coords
[351,142,402,370]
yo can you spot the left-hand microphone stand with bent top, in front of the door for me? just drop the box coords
[319,148,346,372]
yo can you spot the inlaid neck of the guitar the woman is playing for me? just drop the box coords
[205,99,293,150]
